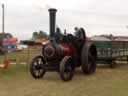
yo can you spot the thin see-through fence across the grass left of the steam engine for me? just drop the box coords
[0,48,42,64]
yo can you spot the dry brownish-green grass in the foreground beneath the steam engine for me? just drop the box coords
[0,49,128,96]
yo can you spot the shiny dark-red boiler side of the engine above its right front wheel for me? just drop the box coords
[60,43,76,57]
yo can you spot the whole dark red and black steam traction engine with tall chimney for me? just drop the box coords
[30,9,97,81]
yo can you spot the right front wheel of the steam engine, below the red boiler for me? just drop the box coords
[59,56,74,81]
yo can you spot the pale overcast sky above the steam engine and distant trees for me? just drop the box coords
[0,0,128,40]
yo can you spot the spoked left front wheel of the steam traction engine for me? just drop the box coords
[30,56,46,79]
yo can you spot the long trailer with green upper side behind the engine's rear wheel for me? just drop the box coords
[91,40,128,68]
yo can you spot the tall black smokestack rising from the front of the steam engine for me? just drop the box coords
[48,8,57,37]
